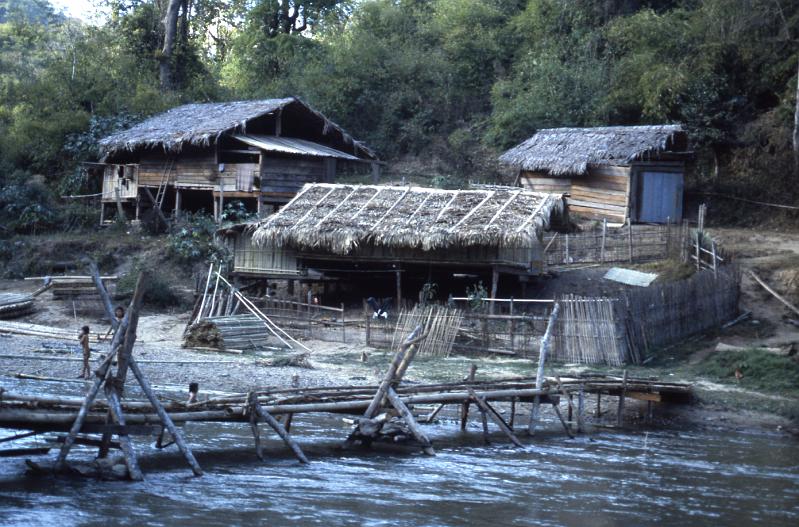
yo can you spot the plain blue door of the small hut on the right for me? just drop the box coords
[638,171,683,223]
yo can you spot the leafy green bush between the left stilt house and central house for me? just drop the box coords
[167,213,228,264]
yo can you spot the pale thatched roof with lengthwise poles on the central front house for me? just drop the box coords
[253,183,563,255]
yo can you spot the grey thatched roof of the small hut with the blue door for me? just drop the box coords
[499,124,686,176]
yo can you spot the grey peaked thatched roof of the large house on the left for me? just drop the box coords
[99,97,376,158]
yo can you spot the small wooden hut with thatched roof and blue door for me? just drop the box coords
[499,125,690,223]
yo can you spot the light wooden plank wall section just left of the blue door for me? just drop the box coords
[567,165,630,223]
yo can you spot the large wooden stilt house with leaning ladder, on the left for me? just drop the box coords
[89,98,378,224]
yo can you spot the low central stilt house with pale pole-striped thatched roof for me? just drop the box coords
[222,183,564,306]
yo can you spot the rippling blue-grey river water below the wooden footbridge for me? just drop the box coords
[0,379,799,527]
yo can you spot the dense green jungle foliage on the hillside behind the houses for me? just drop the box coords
[0,0,799,236]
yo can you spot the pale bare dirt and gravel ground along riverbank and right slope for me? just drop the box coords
[0,225,799,436]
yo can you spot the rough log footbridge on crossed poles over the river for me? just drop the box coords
[0,270,691,480]
